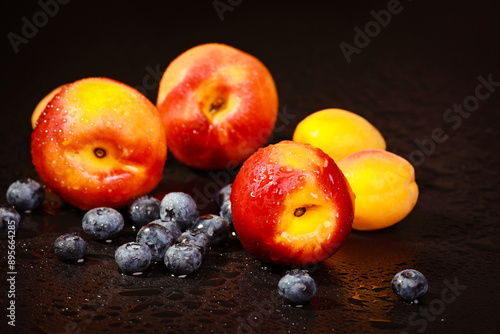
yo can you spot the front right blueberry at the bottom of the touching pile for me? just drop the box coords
[165,243,203,275]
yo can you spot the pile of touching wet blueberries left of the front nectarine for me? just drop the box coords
[115,192,229,276]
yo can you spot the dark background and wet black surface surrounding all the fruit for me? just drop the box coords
[0,0,500,333]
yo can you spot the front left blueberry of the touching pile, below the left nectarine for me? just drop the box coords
[115,241,152,274]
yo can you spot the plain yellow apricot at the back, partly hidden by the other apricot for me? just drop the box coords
[293,108,386,163]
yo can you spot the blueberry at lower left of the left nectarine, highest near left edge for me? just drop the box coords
[7,178,45,211]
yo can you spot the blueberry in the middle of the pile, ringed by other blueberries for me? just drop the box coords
[135,223,174,261]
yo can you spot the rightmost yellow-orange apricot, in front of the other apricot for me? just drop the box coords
[338,150,419,231]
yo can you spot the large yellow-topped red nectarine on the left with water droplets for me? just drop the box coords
[31,78,167,210]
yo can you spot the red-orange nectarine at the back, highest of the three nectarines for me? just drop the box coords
[157,43,278,169]
